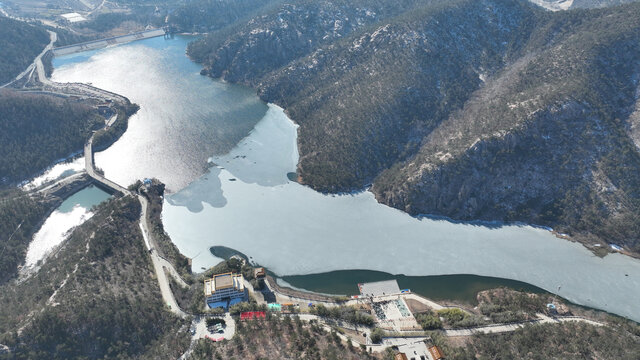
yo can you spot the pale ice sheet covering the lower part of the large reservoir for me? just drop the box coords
[163,106,640,320]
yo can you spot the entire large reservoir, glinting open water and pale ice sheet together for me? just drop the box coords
[53,37,640,320]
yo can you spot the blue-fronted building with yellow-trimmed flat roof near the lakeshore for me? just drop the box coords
[204,273,249,309]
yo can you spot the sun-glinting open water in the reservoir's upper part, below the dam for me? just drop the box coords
[52,37,267,191]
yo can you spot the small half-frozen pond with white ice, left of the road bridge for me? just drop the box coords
[25,186,109,269]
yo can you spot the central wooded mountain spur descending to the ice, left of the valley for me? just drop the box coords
[189,1,534,191]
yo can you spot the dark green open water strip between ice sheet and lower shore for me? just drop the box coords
[281,270,546,305]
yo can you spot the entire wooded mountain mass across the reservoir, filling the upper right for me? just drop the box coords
[181,0,640,251]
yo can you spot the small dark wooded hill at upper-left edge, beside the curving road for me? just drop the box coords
[0,16,49,85]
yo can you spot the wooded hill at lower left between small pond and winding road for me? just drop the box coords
[0,197,189,359]
